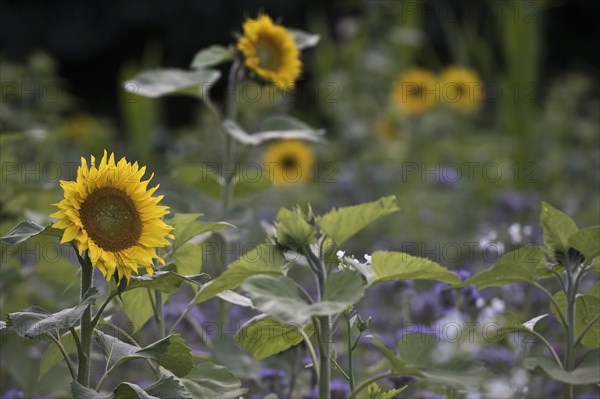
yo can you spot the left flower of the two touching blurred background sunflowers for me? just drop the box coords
[393,68,438,114]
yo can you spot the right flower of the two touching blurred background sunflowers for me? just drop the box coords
[440,66,483,112]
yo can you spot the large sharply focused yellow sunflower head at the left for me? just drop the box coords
[50,151,173,280]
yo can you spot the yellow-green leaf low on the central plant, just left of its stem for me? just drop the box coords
[235,314,314,360]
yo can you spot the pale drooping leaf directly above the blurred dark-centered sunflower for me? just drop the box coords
[221,119,325,145]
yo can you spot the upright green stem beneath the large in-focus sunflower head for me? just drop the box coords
[77,252,94,387]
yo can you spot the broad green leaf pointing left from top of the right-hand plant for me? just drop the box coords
[453,245,548,290]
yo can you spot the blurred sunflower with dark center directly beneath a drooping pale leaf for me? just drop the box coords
[263,140,315,186]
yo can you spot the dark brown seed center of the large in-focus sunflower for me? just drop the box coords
[79,187,142,252]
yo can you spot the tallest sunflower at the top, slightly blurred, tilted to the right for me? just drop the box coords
[237,15,302,89]
